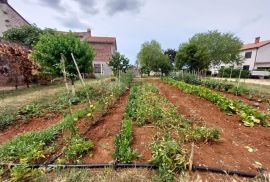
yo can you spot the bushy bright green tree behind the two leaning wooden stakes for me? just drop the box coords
[31,33,94,84]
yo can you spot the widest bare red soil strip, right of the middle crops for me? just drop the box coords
[151,80,270,172]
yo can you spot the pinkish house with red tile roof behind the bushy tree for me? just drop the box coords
[76,29,117,76]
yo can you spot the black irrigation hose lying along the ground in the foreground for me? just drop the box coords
[0,163,264,178]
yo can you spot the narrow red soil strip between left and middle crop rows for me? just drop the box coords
[82,92,129,163]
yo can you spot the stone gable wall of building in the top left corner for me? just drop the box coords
[0,0,30,37]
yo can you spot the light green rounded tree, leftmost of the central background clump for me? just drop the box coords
[137,40,167,75]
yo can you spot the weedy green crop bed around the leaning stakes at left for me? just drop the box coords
[0,75,132,181]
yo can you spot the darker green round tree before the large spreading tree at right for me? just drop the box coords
[175,43,210,71]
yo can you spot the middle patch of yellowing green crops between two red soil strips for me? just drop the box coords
[113,83,220,181]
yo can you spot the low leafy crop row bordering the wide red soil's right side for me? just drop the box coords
[163,78,270,127]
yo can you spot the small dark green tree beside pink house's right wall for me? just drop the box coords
[109,52,129,76]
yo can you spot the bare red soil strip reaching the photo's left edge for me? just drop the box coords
[0,114,61,144]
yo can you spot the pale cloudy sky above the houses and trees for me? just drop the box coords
[9,0,270,64]
